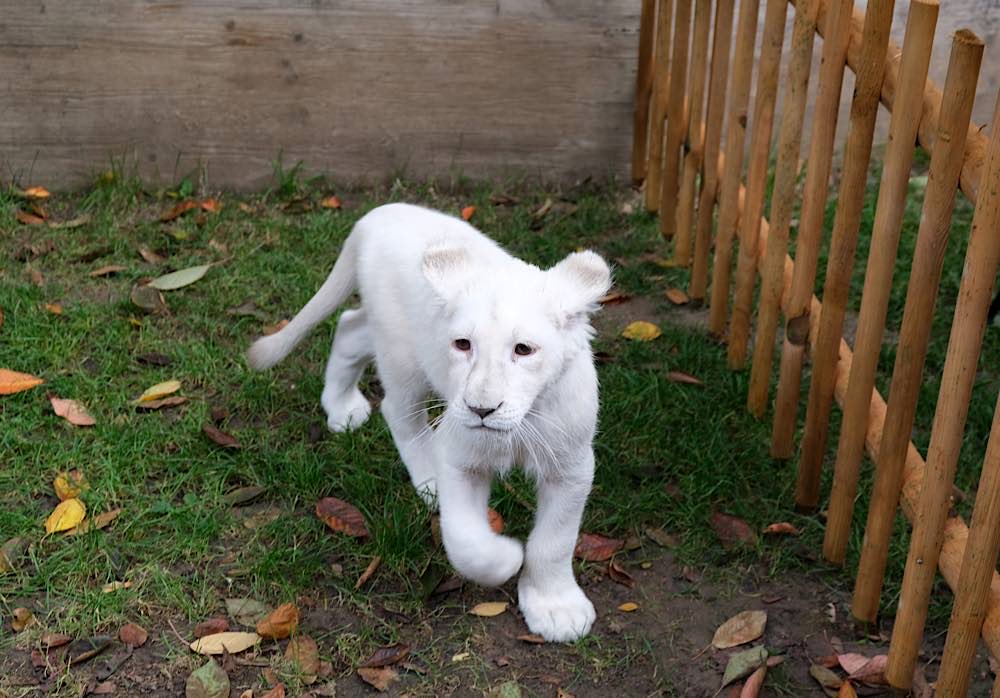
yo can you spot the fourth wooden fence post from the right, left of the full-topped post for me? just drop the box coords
[823,0,936,564]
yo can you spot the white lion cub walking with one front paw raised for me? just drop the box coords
[247,204,611,642]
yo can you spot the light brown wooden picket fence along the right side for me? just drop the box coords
[632,0,1000,697]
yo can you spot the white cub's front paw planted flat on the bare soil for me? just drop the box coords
[517,578,597,642]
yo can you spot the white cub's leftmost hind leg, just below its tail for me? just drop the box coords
[320,308,375,432]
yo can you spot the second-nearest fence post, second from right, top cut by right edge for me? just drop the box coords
[886,29,1000,688]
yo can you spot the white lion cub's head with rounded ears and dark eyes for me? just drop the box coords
[423,247,611,435]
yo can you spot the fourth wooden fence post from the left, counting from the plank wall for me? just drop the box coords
[674,0,712,267]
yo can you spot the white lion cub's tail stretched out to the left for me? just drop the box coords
[247,232,357,370]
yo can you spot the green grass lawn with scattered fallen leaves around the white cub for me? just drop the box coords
[0,168,1000,692]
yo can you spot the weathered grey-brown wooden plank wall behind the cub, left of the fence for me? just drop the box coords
[0,0,641,189]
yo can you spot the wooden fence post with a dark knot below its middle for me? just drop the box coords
[771,0,854,458]
